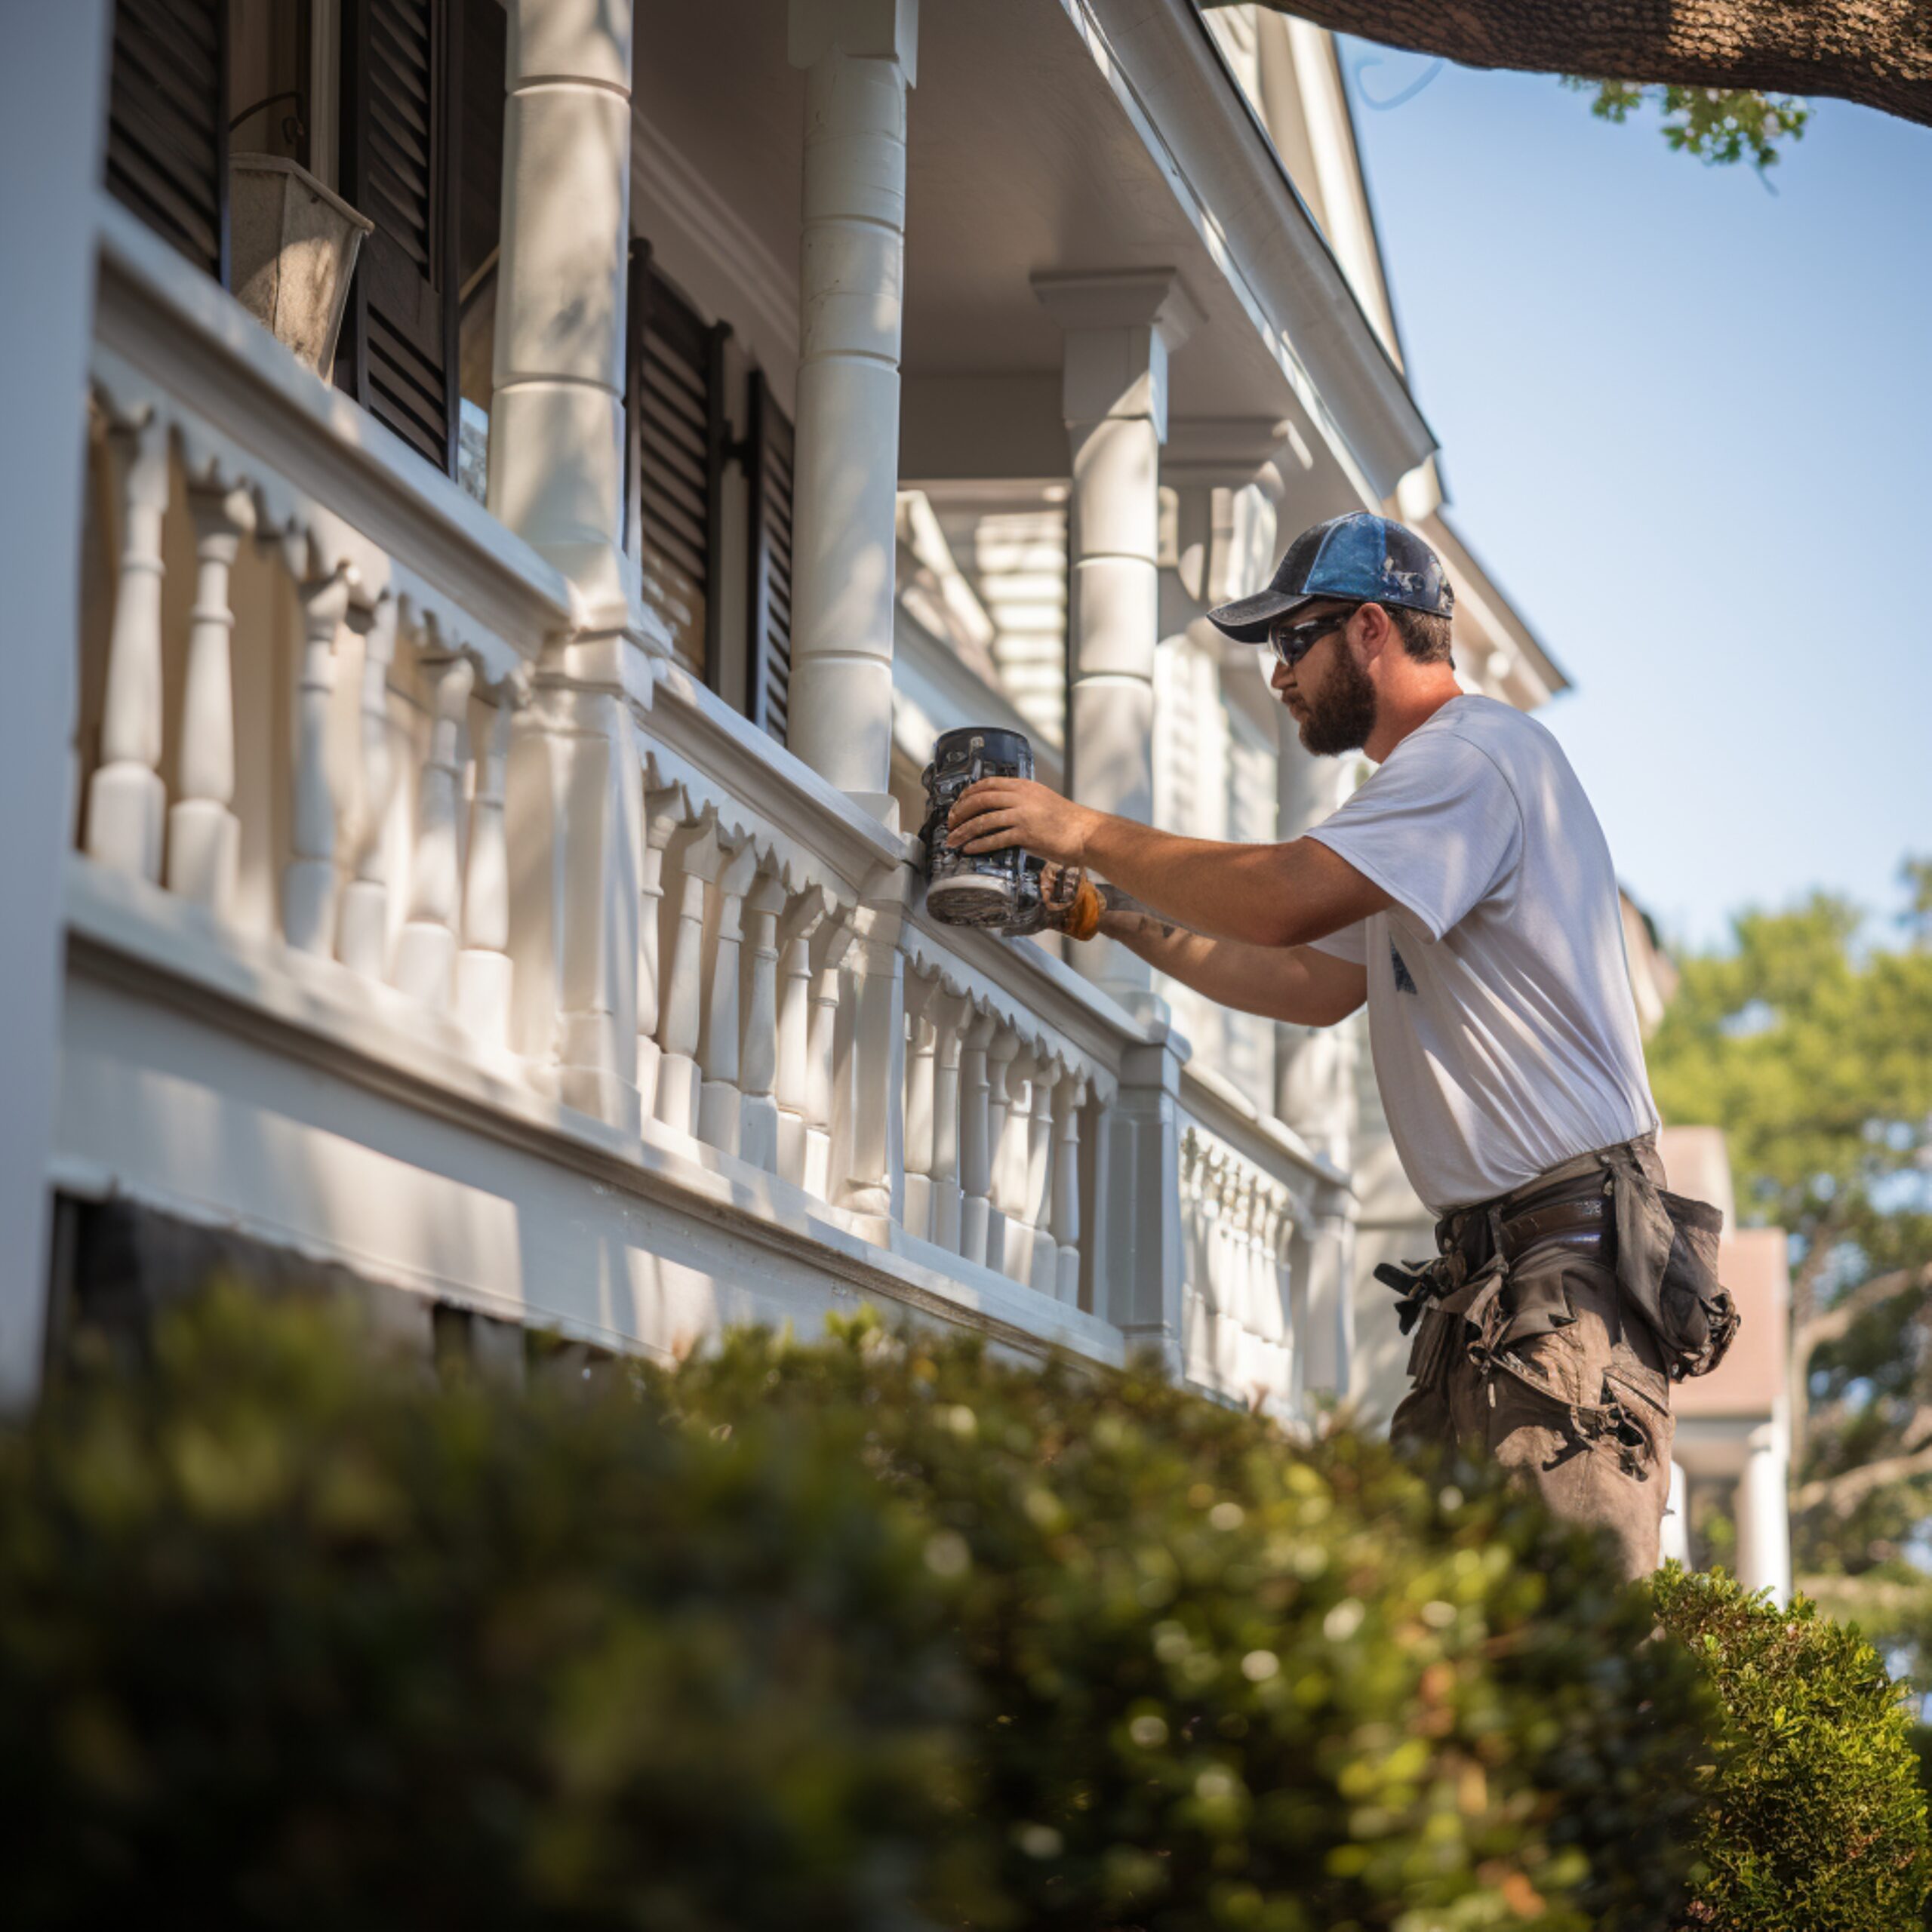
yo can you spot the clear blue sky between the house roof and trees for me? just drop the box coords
[1343,41,1932,943]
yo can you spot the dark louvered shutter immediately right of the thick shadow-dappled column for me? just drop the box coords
[624,242,731,686]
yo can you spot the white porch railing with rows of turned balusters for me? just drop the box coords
[73,195,1337,1407]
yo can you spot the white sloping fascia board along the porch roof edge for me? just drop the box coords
[1060,0,1435,500]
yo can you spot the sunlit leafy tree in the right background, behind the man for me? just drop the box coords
[1648,862,1932,1684]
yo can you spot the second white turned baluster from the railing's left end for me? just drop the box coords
[168,485,255,918]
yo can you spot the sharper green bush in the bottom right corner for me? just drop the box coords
[1656,1563,1932,1932]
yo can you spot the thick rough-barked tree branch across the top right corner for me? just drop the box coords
[1236,0,1932,124]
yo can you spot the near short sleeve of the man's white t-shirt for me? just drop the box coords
[1308,728,1522,939]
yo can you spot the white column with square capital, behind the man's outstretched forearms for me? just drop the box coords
[1034,269,1196,1003]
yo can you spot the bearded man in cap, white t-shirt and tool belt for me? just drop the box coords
[949,514,1735,1577]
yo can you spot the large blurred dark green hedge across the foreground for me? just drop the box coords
[0,1294,1715,1932]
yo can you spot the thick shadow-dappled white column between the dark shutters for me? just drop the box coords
[489,0,632,630]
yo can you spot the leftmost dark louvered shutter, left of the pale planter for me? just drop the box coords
[106,0,228,284]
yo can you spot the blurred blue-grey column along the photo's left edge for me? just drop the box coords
[0,0,112,1408]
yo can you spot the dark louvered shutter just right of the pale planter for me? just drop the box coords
[336,0,460,473]
